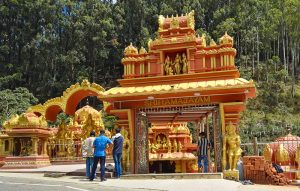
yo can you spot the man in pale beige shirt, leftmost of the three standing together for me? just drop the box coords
[82,131,95,178]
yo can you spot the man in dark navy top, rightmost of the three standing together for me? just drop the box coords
[112,128,124,178]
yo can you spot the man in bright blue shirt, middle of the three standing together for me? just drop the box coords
[90,130,112,182]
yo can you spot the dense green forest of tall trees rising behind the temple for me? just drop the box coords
[0,0,300,142]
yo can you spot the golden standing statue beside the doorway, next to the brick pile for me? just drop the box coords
[222,122,242,170]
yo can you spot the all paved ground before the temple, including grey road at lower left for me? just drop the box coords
[0,164,300,191]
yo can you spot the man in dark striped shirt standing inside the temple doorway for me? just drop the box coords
[197,132,210,172]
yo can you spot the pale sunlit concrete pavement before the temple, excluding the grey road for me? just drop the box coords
[0,164,300,191]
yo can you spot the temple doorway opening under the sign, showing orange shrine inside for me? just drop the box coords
[135,104,222,174]
